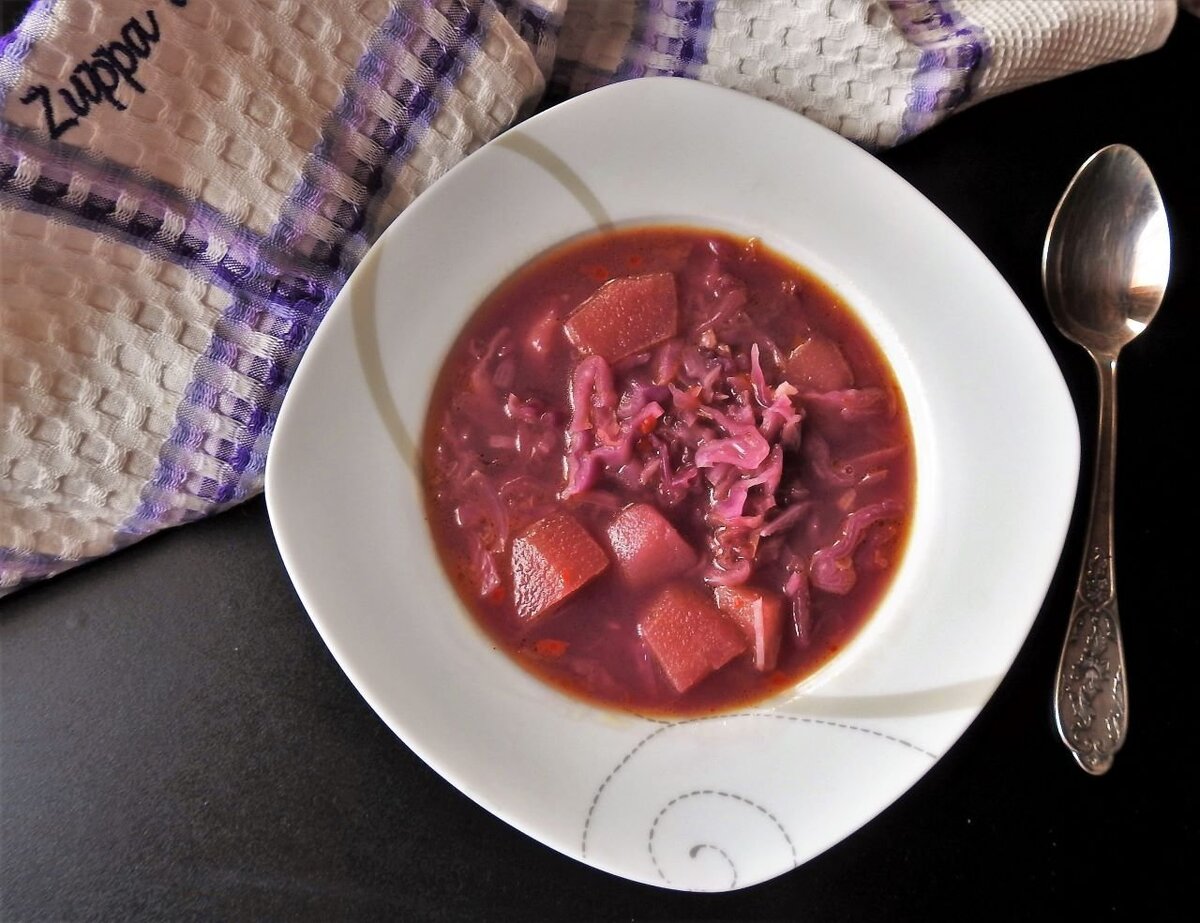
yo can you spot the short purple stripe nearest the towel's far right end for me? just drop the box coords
[888,0,990,140]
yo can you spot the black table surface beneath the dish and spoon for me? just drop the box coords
[0,9,1200,921]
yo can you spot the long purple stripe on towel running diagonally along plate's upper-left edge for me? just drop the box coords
[121,0,492,535]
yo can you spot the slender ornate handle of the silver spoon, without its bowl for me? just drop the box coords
[1055,355,1129,775]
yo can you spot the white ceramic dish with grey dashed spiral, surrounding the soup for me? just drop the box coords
[266,78,1079,891]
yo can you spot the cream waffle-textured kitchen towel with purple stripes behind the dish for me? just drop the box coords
[0,0,1175,593]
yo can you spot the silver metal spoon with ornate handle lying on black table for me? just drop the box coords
[1042,144,1171,775]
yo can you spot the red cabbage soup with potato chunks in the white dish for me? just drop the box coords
[422,227,916,715]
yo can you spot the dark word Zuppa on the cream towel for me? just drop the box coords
[20,0,187,140]
